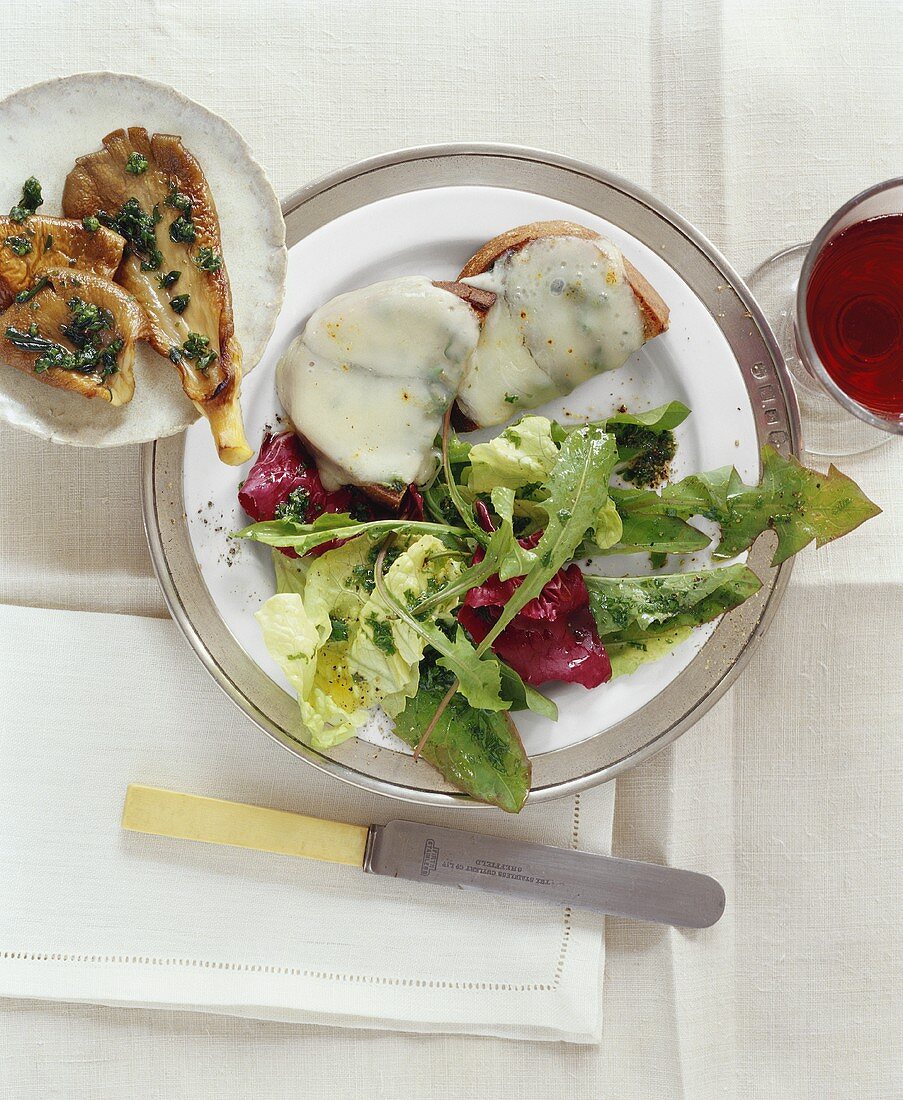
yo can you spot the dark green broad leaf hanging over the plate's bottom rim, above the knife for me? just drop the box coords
[395,669,531,814]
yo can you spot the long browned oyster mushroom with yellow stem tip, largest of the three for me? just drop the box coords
[63,127,252,465]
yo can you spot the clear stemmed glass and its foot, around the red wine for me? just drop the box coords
[748,177,903,458]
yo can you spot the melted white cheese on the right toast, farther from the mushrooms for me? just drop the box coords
[459,237,643,427]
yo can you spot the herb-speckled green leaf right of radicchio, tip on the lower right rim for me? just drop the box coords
[584,564,762,648]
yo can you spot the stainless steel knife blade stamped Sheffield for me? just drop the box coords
[364,821,725,928]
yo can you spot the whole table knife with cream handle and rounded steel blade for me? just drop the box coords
[122,784,725,928]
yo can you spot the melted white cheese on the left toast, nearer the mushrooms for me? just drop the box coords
[276,275,480,488]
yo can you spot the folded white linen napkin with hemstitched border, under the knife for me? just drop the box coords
[0,605,614,1043]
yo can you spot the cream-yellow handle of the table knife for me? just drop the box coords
[122,784,370,867]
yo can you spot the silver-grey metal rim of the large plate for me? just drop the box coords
[141,143,801,809]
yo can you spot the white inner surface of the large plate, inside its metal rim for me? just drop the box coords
[185,187,759,756]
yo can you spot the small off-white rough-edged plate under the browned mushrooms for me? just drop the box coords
[0,73,286,451]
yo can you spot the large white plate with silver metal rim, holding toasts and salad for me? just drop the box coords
[144,146,796,802]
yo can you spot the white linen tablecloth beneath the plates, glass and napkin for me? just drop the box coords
[0,0,903,1100]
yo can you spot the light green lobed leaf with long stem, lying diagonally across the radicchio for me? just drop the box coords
[476,426,617,653]
